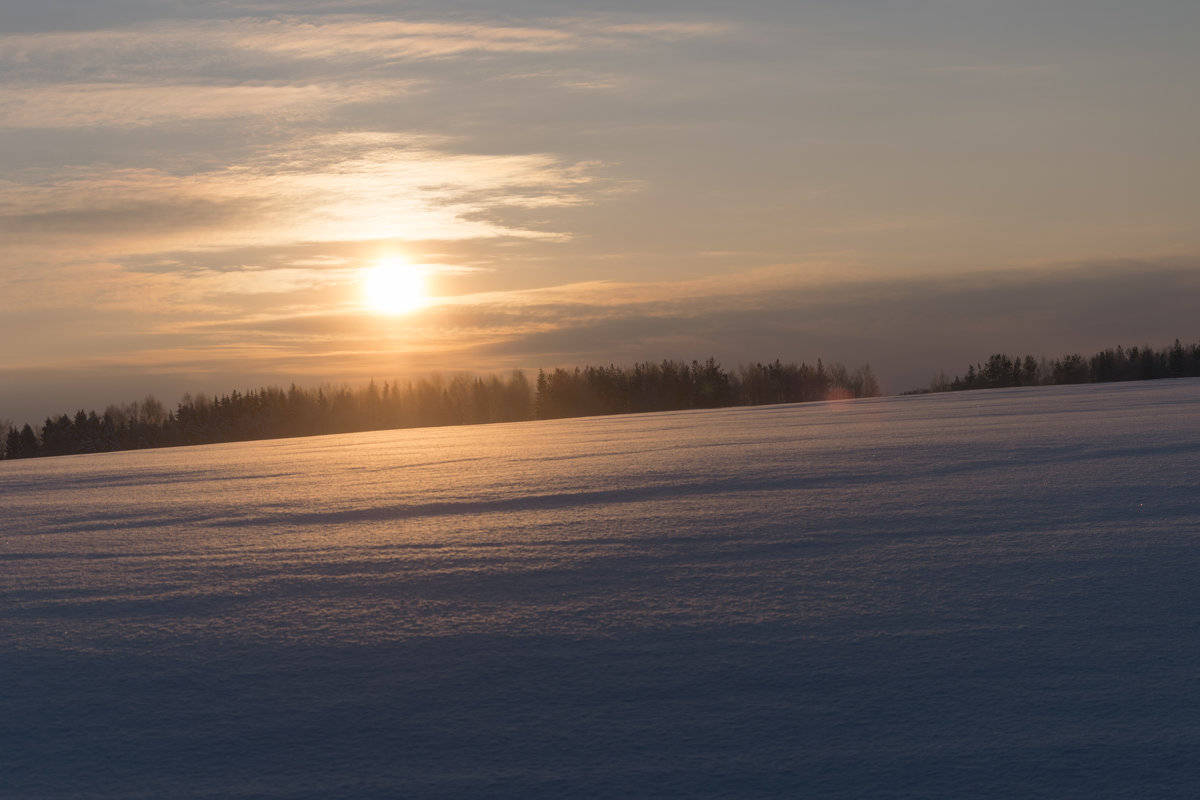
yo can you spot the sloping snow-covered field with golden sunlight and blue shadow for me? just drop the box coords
[0,380,1200,800]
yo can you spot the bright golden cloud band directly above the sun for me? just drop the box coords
[0,132,611,299]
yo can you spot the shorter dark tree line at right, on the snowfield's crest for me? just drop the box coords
[922,339,1200,392]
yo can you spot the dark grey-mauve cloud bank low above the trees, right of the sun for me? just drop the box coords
[398,258,1200,391]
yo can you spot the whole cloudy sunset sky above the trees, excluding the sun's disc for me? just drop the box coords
[0,0,1200,423]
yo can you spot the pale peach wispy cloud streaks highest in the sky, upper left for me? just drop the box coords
[0,16,719,128]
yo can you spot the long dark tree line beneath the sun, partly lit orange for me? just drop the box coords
[0,359,880,458]
